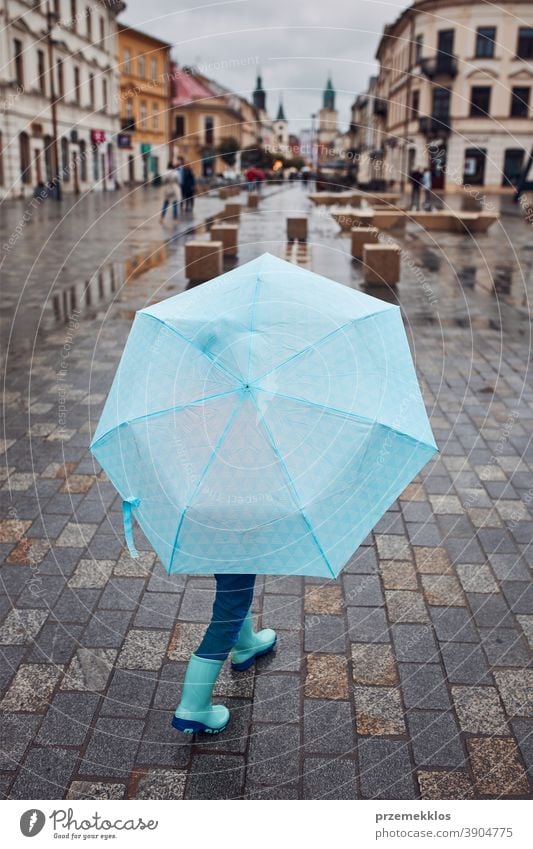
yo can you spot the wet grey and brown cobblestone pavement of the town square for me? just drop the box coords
[0,182,533,799]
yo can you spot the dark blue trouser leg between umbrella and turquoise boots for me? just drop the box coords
[195,575,255,660]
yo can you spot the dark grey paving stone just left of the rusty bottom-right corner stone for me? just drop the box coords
[407,711,465,768]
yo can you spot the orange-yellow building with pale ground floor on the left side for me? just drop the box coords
[117,26,172,183]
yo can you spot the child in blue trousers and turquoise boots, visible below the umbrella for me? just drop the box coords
[172,574,276,734]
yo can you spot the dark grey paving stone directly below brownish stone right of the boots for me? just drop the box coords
[304,699,355,755]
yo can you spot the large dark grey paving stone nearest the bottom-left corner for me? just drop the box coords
[9,746,78,800]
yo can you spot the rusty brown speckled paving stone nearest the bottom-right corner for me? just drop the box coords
[467,737,529,797]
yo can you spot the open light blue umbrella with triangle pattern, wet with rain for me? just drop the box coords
[91,254,437,577]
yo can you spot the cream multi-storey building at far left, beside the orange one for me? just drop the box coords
[0,0,124,197]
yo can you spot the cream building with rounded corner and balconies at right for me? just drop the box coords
[352,0,533,191]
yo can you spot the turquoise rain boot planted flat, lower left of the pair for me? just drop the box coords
[172,654,229,734]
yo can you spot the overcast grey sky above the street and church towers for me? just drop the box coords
[120,0,409,133]
